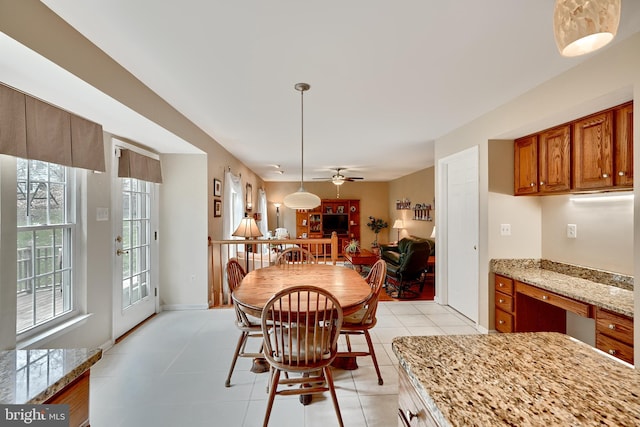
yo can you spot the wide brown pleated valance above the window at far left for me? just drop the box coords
[0,84,106,172]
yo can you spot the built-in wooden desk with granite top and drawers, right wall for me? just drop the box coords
[491,260,633,364]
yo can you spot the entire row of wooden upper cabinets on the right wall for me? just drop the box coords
[514,102,633,196]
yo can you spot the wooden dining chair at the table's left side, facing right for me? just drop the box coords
[224,258,264,387]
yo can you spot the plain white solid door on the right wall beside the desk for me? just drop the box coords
[445,147,479,322]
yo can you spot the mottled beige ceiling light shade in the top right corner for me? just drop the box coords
[553,0,620,57]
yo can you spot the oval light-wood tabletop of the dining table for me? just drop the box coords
[232,263,371,317]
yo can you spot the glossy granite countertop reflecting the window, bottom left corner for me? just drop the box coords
[0,348,102,404]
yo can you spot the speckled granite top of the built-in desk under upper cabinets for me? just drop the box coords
[490,259,633,317]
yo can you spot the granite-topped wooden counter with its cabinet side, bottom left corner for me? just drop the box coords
[0,348,102,427]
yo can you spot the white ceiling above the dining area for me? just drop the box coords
[21,0,640,181]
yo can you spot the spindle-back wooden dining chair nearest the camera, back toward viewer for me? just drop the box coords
[262,286,344,427]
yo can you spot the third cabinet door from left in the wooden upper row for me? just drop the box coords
[572,111,613,190]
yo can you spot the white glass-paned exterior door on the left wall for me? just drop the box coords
[112,145,157,338]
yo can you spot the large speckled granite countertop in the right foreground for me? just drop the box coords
[393,332,640,426]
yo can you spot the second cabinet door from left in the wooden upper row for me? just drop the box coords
[538,125,571,193]
